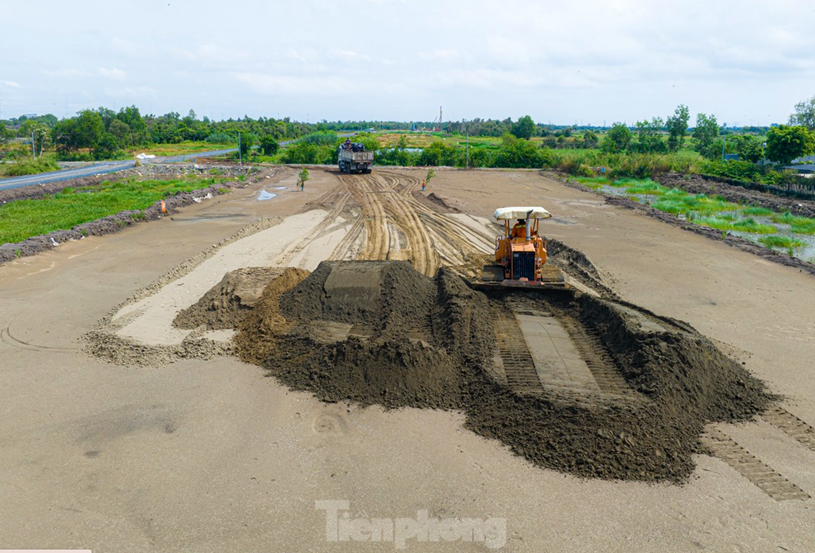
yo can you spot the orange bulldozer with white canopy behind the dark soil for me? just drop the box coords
[473,206,567,290]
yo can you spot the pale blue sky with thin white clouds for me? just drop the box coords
[0,0,815,126]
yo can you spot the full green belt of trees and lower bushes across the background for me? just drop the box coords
[0,97,815,188]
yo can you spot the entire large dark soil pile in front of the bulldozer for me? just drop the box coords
[236,262,770,482]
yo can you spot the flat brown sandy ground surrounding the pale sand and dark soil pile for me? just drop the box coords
[0,170,815,551]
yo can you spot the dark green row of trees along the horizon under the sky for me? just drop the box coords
[0,97,815,163]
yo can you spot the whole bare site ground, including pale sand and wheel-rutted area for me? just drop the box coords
[0,167,815,552]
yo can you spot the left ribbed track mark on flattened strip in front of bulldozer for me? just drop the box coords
[490,303,543,393]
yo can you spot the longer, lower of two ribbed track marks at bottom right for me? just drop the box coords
[701,428,810,501]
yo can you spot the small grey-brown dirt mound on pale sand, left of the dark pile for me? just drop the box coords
[173,267,283,330]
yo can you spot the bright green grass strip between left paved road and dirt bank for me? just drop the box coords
[0,178,227,244]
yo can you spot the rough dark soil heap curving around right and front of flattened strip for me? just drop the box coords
[465,295,772,483]
